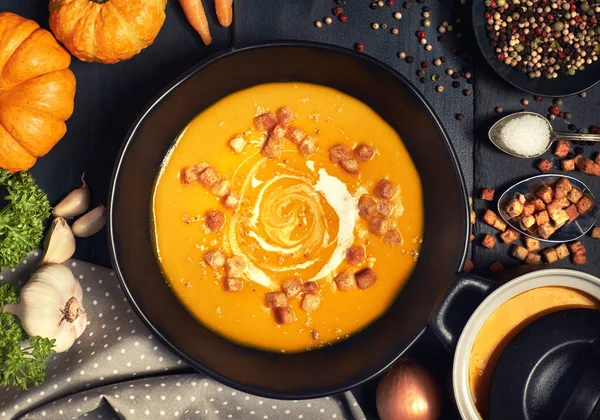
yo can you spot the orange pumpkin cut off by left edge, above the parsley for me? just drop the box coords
[0,12,75,172]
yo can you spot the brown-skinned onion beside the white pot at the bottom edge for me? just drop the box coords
[377,359,440,420]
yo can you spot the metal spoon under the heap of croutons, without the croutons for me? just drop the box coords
[498,174,600,243]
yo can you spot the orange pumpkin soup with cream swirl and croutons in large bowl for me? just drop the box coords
[152,83,423,352]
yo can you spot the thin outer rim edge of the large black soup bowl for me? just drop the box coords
[106,40,471,400]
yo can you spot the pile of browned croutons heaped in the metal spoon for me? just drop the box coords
[504,178,594,239]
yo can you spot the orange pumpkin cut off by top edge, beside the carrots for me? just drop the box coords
[50,0,167,64]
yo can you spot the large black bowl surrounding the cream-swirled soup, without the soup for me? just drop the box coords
[108,42,469,399]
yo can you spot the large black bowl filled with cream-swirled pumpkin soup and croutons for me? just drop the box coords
[109,42,468,399]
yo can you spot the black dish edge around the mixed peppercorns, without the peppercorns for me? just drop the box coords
[472,0,600,97]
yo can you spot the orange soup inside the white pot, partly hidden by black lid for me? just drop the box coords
[469,286,600,419]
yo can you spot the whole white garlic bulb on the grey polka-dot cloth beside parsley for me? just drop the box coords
[19,264,87,353]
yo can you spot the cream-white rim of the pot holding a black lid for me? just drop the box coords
[452,268,600,420]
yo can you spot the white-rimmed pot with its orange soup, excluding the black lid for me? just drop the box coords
[453,269,600,420]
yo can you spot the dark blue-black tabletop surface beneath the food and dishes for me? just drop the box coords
[1,0,600,419]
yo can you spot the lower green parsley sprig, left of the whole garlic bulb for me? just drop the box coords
[0,283,54,390]
